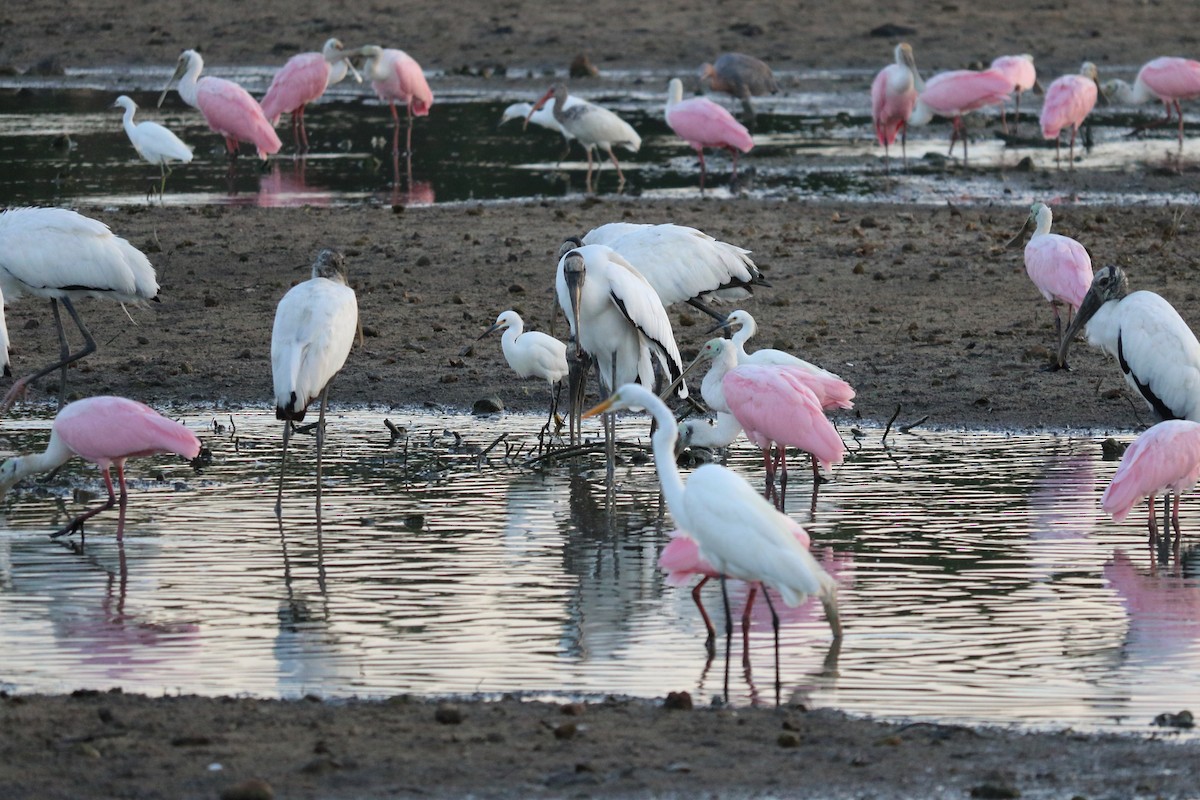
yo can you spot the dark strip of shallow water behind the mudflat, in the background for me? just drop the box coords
[7,66,1200,206]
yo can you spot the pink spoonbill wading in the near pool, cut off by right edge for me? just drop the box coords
[1100,420,1200,553]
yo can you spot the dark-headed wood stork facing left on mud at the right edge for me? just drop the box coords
[1058,265,1200,422]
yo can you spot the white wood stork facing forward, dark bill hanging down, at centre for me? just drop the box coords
[554,236,688,480]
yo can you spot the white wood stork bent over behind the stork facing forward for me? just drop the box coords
[583,222,770,323]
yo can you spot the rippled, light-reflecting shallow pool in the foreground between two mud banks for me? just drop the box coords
[0,410,1200,730]
